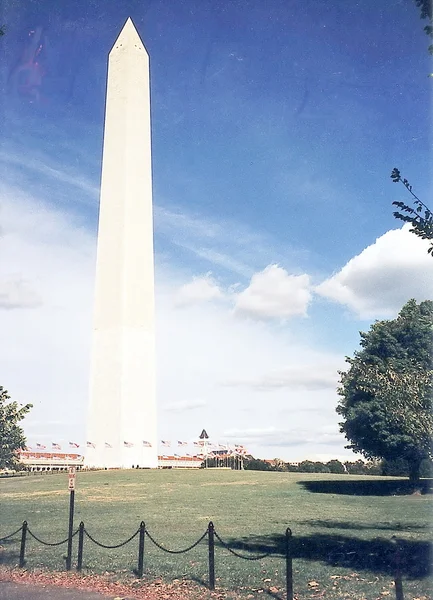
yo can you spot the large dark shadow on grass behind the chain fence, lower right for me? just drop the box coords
[218,534,431,579]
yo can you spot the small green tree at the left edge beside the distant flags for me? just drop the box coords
[0,386,32,469]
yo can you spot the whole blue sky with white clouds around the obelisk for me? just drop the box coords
[0,0,433,460]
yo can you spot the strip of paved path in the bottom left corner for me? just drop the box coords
[0,581,126,600]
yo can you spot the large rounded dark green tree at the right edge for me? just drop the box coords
[337,300,433,481]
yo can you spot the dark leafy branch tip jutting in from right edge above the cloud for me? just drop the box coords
[391,168,433,255]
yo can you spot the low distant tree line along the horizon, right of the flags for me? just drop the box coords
[244,457,433,477]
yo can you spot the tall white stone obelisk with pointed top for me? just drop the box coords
[86,19,157,468]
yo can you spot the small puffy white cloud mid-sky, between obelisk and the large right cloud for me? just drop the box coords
[235,265,311,319]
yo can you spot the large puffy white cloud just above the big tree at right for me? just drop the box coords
[315,225,433,319]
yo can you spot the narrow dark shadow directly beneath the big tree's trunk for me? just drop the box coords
[298,478,433,496]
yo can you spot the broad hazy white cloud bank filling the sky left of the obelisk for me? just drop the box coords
[0,189,95,437]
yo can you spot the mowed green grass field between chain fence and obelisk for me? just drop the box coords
[0,469,433,598]
